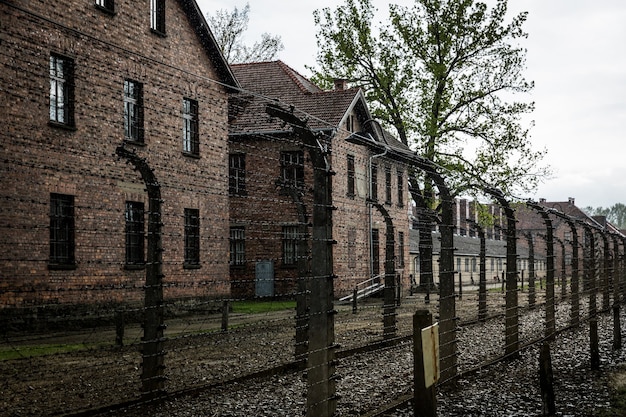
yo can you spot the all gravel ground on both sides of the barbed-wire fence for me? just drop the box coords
[0,293,626,417]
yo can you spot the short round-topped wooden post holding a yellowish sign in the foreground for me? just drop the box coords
[413,310,437,417]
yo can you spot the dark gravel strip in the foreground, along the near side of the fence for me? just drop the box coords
[116,298,626,417]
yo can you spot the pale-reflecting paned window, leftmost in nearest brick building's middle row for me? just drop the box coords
[50,55,74,127]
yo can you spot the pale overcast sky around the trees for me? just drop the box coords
[197,0,626,207]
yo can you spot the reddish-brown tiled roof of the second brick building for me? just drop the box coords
[229,61,365,134]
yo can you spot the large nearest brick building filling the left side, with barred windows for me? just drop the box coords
[0,0,236,308]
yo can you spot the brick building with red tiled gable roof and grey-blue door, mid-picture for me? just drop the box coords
[229,61,409,297]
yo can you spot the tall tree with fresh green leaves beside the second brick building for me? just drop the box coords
[310,0,549,284]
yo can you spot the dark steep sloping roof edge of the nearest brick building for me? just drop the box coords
[178,0,239,87]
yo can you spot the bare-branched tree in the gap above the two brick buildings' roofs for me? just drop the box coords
[207,3,284,64]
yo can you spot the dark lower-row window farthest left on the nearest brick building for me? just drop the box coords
[50,193,75,266]
